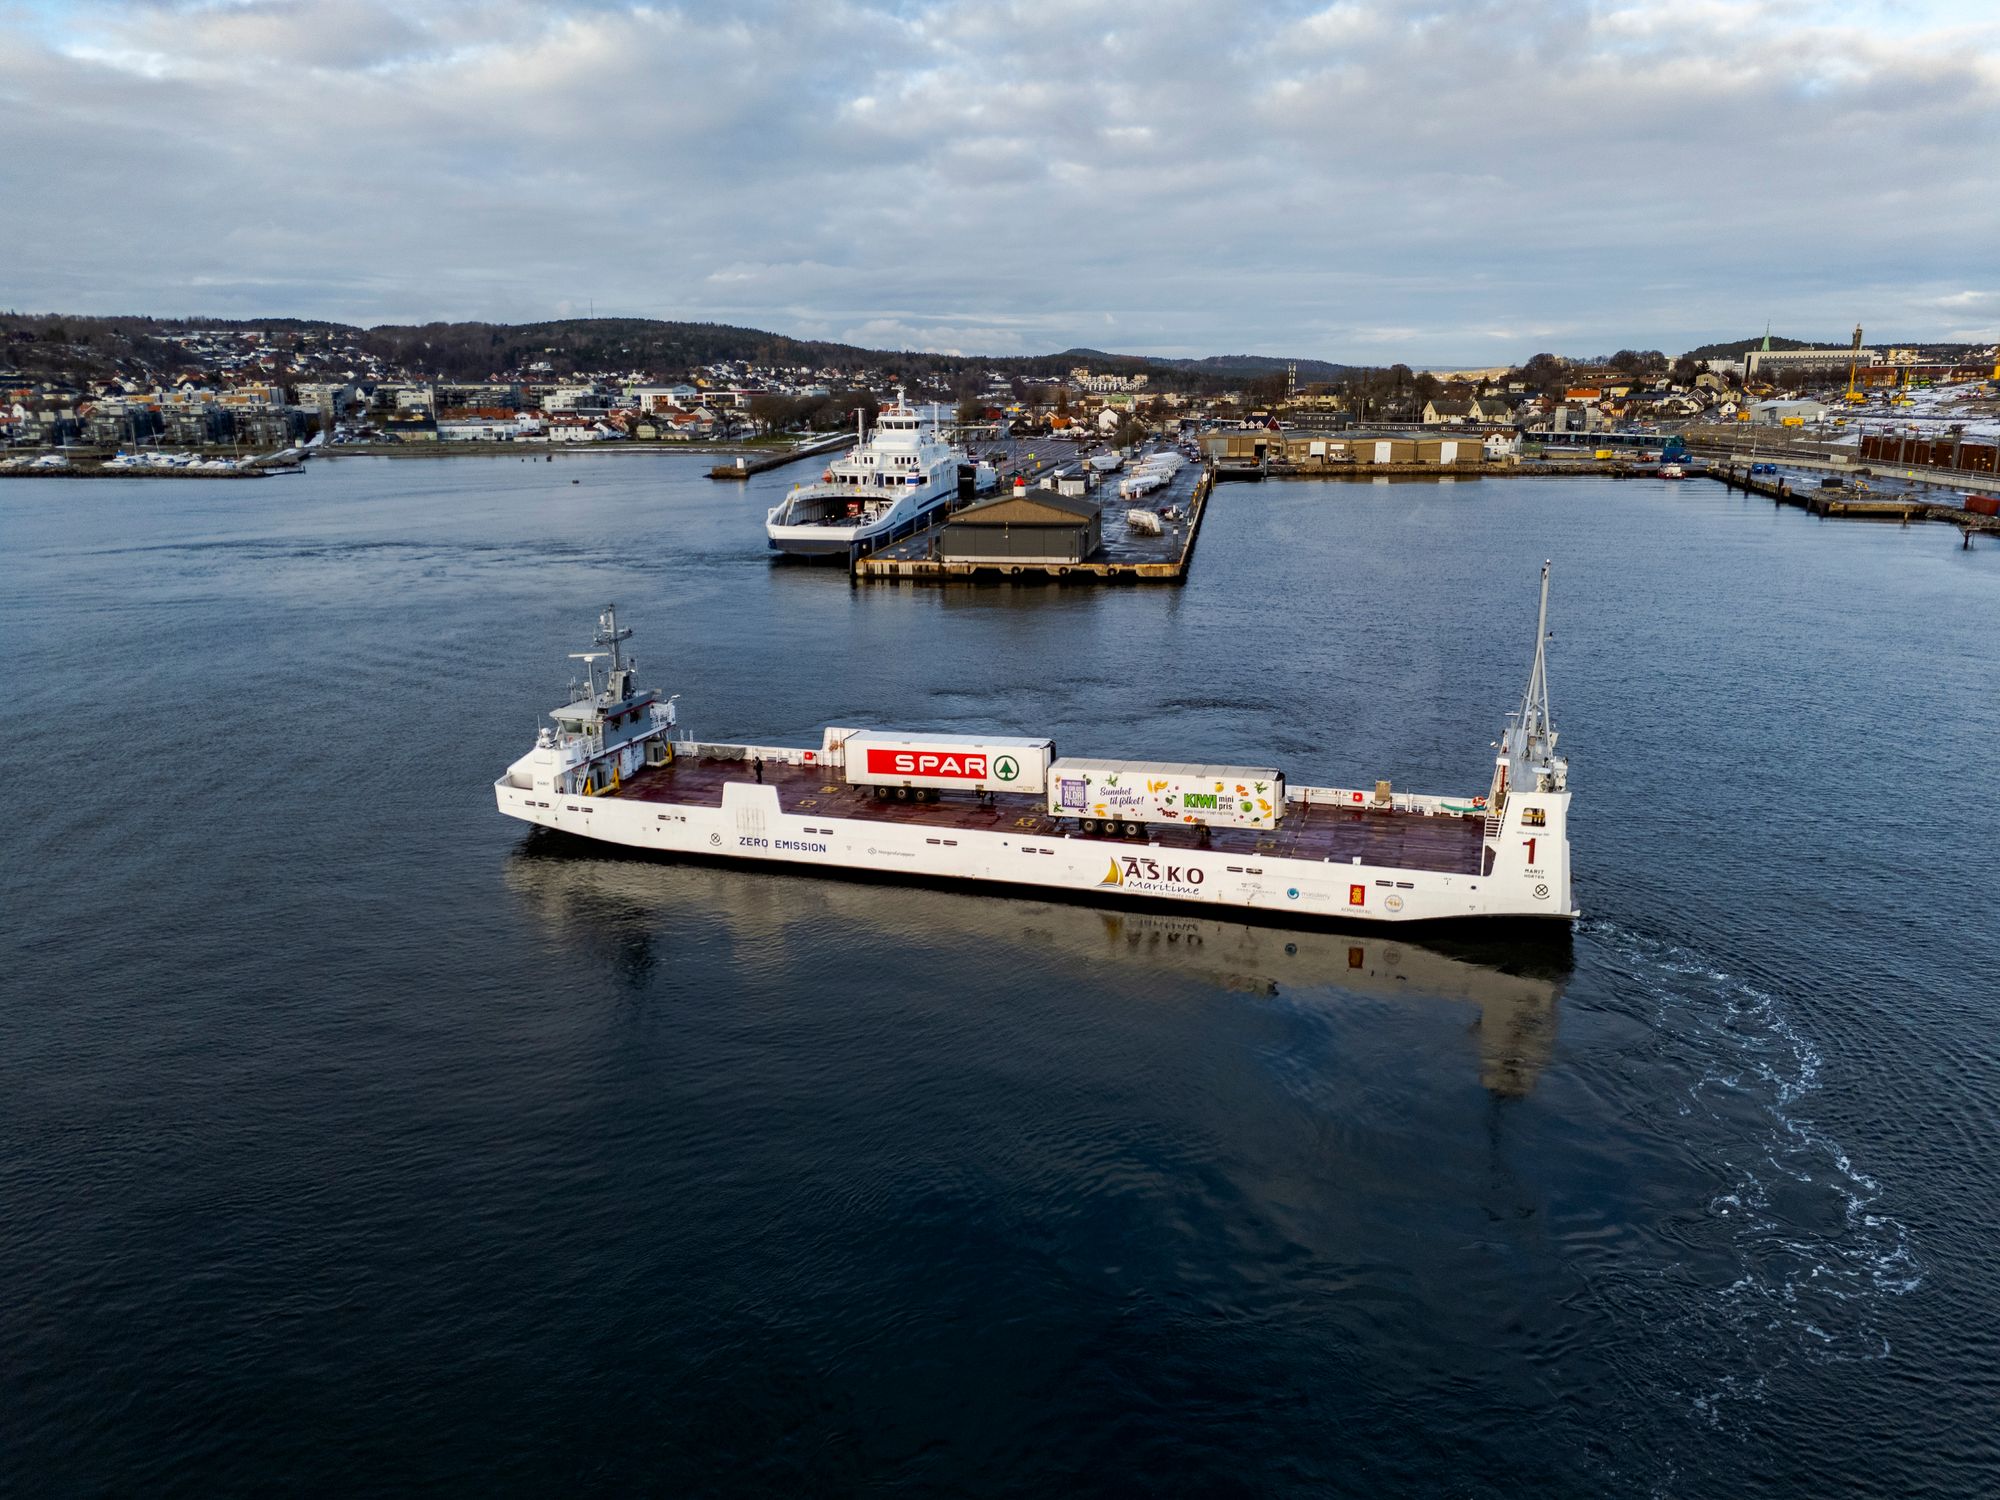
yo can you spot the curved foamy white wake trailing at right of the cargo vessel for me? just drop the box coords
[1580,922,1922,1426]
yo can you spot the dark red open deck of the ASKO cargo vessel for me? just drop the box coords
[616,760,1484,874]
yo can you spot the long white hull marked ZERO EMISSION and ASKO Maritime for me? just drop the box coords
[494,746,1578,922]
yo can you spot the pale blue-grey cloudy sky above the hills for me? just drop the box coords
[0,0,2000,364]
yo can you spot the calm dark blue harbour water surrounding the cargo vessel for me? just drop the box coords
[0,458,2000,1496]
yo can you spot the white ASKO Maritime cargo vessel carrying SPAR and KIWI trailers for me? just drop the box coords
[494,564,1578,922]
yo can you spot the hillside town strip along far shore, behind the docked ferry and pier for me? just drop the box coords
[0,314,2000,474]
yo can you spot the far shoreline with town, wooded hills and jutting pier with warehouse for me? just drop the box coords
[0,314,2000,568]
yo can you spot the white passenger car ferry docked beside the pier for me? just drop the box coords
[764,392,992,560]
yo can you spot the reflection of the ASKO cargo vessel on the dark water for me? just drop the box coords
[504,828,1570,1098]
